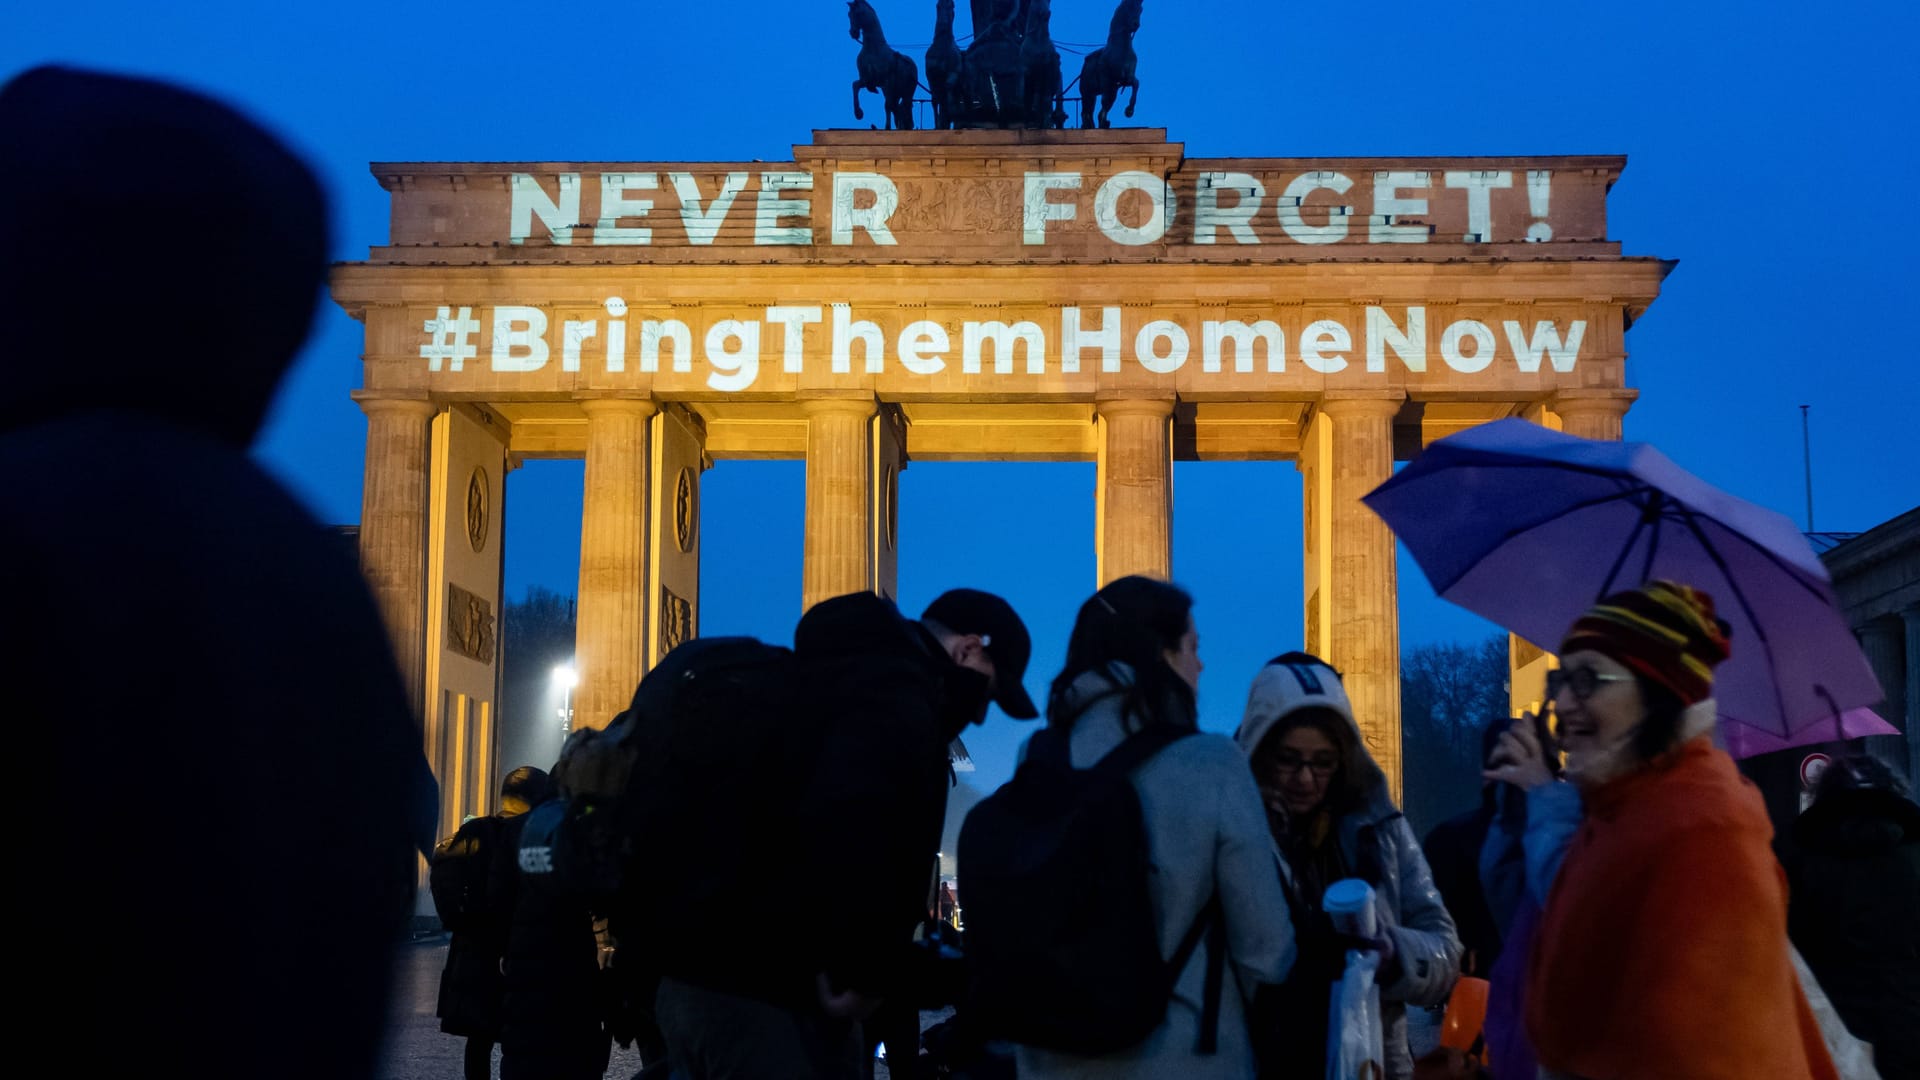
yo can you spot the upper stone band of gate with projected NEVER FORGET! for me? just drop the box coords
[374,129,1626,263]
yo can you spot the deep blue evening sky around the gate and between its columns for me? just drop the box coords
[11,0,1920,784]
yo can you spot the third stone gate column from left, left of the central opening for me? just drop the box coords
[801,394,879,607]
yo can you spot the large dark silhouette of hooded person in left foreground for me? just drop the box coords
[0,67,436,1078]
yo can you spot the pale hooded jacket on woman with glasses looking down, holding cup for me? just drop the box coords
[1235,665,1461,1080]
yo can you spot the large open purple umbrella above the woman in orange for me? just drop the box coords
[1365,419,1884,736]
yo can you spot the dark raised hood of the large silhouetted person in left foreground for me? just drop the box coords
[0,67,328,446]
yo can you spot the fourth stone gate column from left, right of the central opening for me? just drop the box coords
[1094,398,1173,586]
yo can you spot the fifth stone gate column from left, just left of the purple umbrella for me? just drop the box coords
[1302,390,1405,801]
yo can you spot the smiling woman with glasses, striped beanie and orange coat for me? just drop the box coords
[1496,582,1836,1080]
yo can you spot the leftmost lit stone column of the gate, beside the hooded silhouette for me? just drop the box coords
[353,390,440,717]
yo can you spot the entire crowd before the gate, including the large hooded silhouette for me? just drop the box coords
[11,69,1920,1080]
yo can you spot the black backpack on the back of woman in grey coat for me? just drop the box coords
[960,724,1225,1055]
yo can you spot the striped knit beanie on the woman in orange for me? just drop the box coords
[1559,580,1728,705]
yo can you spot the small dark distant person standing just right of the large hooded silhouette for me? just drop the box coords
[432,765,553,1080]
